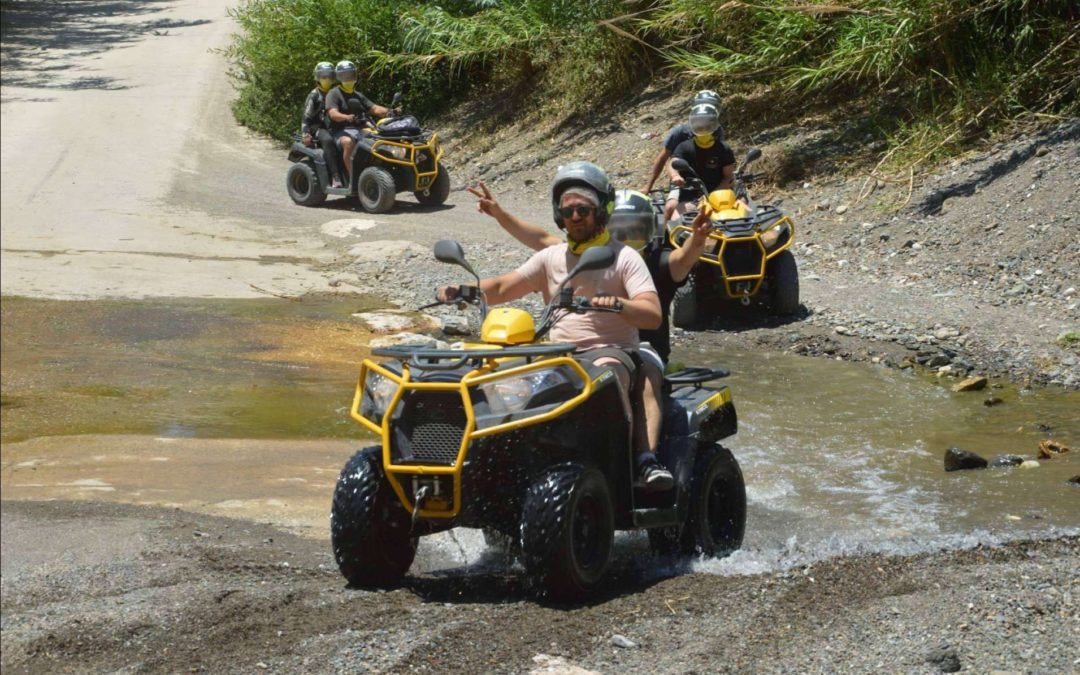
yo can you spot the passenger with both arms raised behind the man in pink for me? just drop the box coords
[468,181,710,481]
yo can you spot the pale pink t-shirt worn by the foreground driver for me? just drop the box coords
[516,241,657,349]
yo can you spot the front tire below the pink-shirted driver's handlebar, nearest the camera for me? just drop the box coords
[522,463,615,603]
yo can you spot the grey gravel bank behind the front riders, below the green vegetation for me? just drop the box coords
[349,105,1080,389]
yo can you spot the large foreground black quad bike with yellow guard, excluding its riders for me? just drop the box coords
[330,241,746,602]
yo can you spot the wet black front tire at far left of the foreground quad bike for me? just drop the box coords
[330,447,417,589]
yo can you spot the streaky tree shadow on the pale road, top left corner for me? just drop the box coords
[0,0,211,90]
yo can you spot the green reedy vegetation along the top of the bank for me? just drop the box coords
[229,0,1080,164]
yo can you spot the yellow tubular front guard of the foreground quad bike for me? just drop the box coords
[350,356,594,519]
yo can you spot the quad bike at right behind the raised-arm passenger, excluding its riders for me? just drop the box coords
[667,148,799,328]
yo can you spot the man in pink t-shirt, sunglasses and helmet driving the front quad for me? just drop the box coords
[438,162,674,491]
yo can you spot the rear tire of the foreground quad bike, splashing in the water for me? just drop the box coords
[680,443,746,557]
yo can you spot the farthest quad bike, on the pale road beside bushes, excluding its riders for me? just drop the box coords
[285,94,450,213]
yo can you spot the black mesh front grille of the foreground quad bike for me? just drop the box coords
[390,391,465,465]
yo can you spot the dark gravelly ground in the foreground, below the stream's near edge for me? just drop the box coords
[0,502,1080,674]
